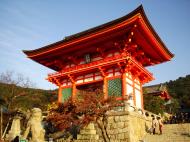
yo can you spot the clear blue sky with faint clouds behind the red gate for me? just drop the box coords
[0,0,190,89]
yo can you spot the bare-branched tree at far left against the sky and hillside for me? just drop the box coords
[0,71,34,110]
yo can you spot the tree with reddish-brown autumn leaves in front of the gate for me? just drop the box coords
[47,92,121,142]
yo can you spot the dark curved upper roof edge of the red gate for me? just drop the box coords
[23,5,174,60]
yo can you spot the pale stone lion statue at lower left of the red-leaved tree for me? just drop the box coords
[23,108,45,142]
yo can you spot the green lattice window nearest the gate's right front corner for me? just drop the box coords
[108,78,122,96]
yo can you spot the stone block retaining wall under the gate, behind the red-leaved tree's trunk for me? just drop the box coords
[76,105,157,142]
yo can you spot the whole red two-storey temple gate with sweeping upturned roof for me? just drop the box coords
[24,6,173,108]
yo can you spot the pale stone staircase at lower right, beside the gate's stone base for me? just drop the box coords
[142,124,190,142]
